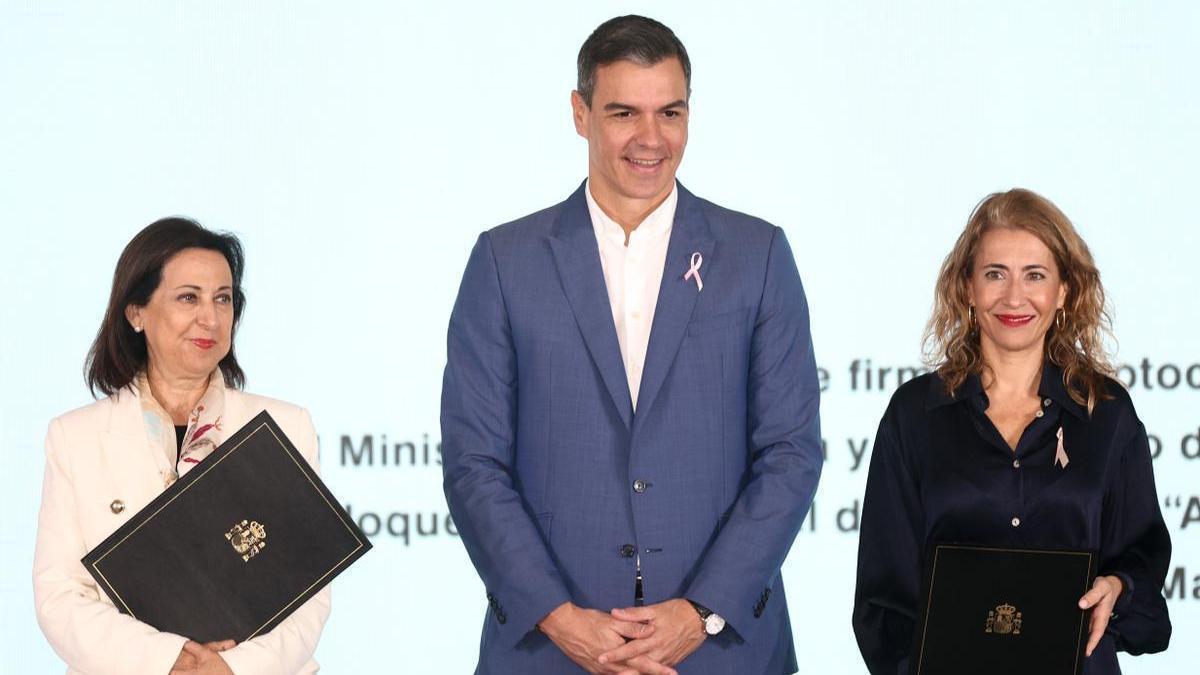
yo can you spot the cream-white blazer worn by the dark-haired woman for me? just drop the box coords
[34,389,330,675]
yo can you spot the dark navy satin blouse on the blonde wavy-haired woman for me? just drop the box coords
[853,363,1171,675]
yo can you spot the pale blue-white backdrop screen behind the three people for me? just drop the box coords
[0,0,1200,674]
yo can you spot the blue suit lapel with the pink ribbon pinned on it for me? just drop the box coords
[637,185,715,425]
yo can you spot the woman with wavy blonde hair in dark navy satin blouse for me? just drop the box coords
[853,190,1171,675]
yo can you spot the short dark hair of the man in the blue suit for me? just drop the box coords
[576,14,691,107]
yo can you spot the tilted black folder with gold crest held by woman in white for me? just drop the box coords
[83,411,371,649]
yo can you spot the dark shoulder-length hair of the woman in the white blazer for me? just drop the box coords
[84,217,246,396]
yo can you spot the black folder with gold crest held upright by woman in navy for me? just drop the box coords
[910,544,1096,675]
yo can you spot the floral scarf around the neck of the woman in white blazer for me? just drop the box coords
[137,371,224,485]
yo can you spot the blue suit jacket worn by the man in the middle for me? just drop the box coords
[442,181,822,674]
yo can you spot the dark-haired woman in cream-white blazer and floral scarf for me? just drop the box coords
[34,219,330,675]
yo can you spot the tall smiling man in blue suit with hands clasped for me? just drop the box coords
[442,17,822,675]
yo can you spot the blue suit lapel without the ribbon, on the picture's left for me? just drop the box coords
[550,181,633,429]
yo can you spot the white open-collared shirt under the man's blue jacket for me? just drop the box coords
[584,181,679,410]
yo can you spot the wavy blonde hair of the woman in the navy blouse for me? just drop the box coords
[923,187,1112,413]
